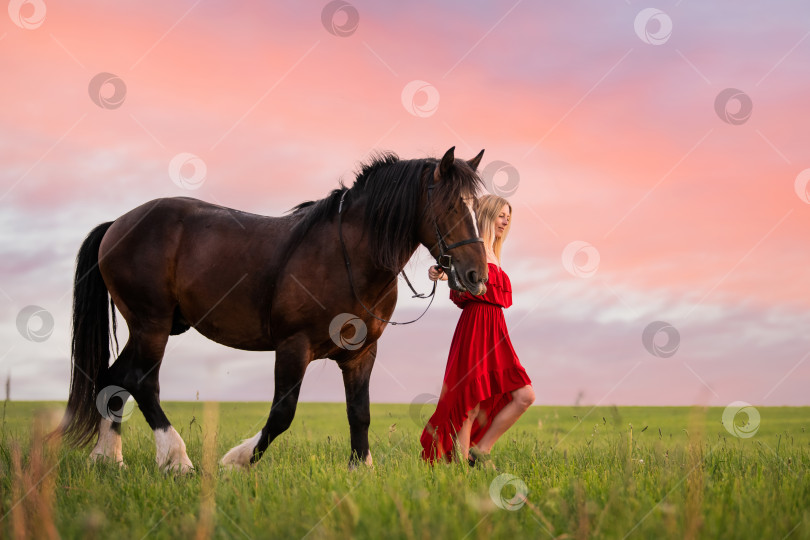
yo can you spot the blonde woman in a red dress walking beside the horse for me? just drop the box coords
[421,195,534,466]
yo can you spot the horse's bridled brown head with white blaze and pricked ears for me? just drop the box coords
[419,147,487,295]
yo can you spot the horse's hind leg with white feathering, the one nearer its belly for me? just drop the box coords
[101,320,194,472]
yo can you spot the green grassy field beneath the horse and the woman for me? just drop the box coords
[0,402,810,540]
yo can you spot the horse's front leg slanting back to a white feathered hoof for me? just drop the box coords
[221,337,312,467]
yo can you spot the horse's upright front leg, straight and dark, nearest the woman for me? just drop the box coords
[340,341,377,469]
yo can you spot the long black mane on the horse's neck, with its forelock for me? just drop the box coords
[288,152,483,273]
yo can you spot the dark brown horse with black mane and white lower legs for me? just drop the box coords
[55,147,487,473]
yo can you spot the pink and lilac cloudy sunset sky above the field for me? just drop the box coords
[0,0,810,406]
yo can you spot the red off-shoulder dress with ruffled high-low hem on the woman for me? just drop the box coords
[420,263,532,463]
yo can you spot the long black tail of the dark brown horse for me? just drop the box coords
[59,221,115,446]
